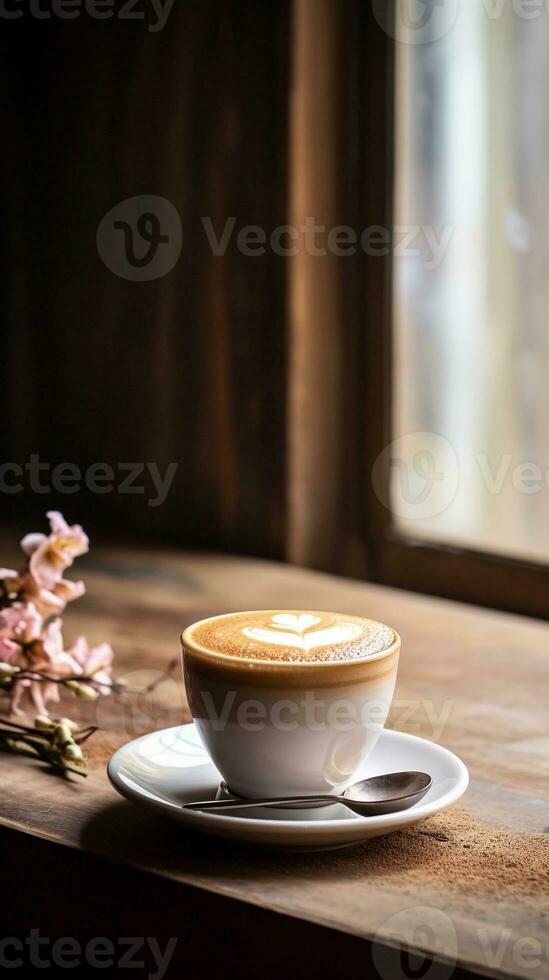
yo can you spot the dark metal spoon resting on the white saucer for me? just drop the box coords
[183,772,432,817]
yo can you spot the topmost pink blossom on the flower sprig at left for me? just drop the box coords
[21,510,89,594]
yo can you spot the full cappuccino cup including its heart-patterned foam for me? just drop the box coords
[181,609,400,798]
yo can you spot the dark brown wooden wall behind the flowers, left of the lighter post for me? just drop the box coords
[0,0,290,556]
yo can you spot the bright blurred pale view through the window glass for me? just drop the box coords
[391,0,549,561]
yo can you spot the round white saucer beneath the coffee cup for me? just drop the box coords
[107,724,469,850]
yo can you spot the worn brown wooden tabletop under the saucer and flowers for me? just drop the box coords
[0,549,549,980]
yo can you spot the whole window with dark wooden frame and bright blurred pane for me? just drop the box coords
[351,0,549,618]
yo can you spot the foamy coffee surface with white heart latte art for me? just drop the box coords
[190,609,396,663]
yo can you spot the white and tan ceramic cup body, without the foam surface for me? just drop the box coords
[181,613,400,798]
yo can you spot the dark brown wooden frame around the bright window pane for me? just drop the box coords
[346,0,549,619]
